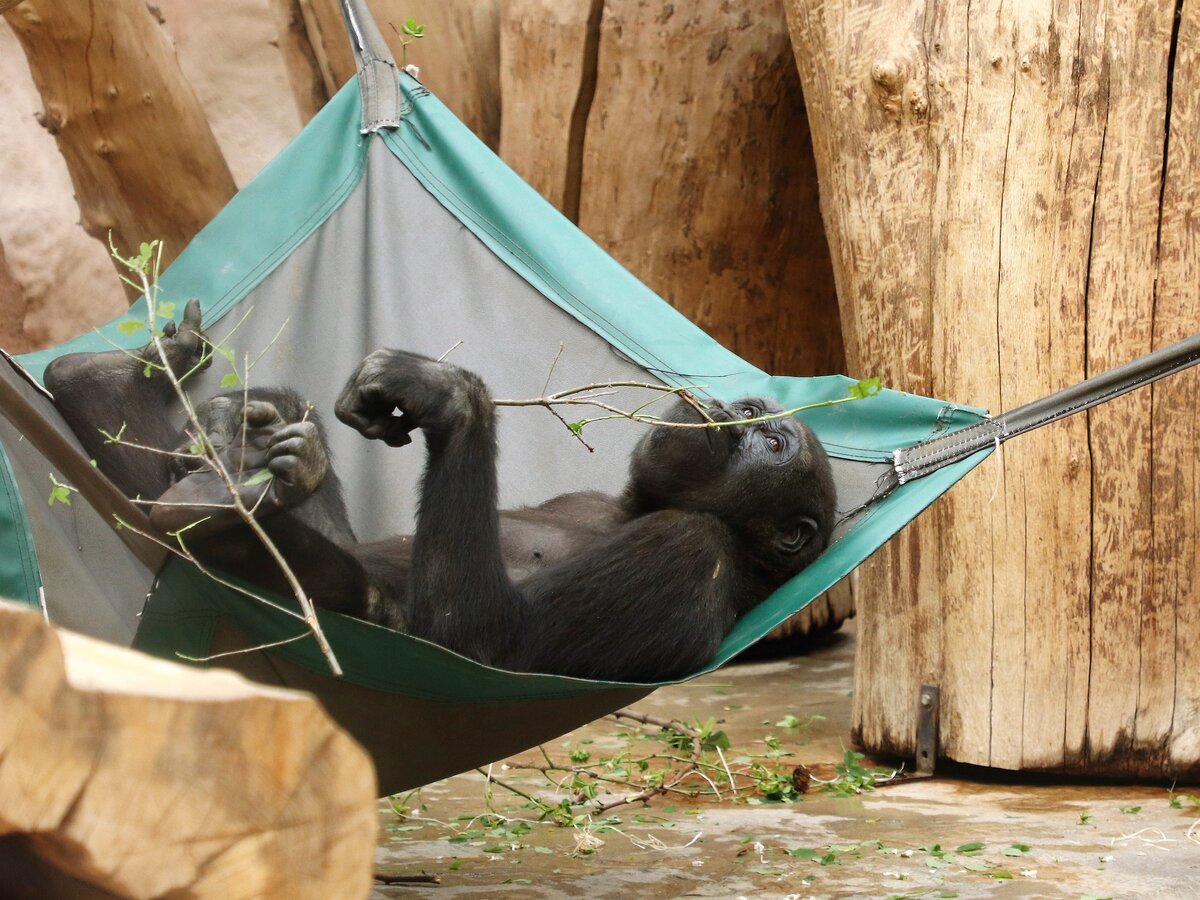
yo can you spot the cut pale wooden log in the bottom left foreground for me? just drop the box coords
[0,604,377,898]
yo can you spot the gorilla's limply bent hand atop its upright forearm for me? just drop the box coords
[335,350,493,446]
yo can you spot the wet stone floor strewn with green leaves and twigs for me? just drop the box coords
[372,628,1200,900]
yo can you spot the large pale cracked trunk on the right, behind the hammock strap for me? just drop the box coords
[786,0,1200,776]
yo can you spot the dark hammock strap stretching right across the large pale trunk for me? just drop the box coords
[893,334,1200,485]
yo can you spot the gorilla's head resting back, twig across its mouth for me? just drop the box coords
[625,397,835,577]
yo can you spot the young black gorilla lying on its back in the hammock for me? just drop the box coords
[46,300,834,680]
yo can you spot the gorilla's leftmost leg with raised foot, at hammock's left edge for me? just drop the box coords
[46,300,208,497]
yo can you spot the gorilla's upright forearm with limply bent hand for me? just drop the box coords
[336,350,524,665]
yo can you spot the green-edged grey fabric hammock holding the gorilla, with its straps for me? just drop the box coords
[0,0,1200,792]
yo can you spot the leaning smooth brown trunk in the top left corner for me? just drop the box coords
[5,0,235,285]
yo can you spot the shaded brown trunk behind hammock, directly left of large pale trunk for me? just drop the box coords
[573,0,844,376]
